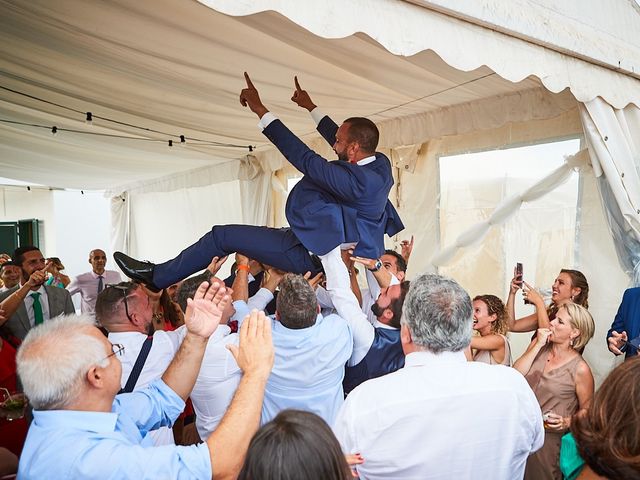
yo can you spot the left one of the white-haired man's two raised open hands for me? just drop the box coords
[184,281,231,338]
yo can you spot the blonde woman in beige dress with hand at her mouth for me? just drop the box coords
[513,303,595,480]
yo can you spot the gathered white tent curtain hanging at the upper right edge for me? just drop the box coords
[580,98,640,285]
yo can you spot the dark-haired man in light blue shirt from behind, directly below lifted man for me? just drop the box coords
[262,274,353,425]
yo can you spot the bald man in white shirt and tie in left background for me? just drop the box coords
[67,248,122,315]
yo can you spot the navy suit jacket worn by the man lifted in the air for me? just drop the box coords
[263,117,404,258]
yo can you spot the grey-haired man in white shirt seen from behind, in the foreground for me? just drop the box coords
[334,274,544,480]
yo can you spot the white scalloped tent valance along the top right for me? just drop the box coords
[198,0,640,108]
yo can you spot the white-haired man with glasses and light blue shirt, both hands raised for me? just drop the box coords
[17,283,274,479]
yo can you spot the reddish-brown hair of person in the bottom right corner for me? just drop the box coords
[571,357,640,478]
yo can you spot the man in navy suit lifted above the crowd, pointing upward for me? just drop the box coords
[114,73,404,289]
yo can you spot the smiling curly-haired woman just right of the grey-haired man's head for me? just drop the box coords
[465,295,511,367]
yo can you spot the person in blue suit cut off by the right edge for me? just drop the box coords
[607,287,640,359]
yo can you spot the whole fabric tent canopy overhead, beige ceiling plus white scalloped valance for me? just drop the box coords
[0,0,640,193]
